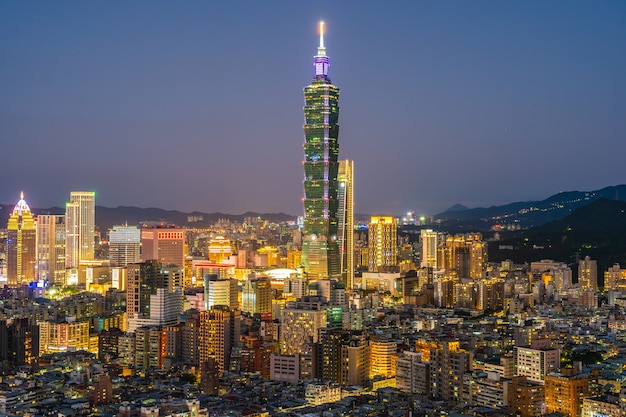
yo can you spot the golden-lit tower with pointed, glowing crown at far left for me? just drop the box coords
[7,193,37,287]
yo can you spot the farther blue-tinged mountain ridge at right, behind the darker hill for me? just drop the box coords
[434,185,626,230]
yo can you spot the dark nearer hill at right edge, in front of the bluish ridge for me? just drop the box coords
[489,199,626,281]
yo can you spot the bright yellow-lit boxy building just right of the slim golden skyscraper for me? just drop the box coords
[368,216,398,272]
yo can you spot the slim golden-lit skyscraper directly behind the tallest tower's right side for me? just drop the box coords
[337,159,354,289]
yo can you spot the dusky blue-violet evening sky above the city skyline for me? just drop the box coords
[0,0,626,215]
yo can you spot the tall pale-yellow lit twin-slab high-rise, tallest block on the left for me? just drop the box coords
[65,191,96,268]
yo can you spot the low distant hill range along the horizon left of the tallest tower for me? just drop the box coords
[0,204,296,231]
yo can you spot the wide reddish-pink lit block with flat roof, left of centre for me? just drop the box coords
[141,225,185,266]
